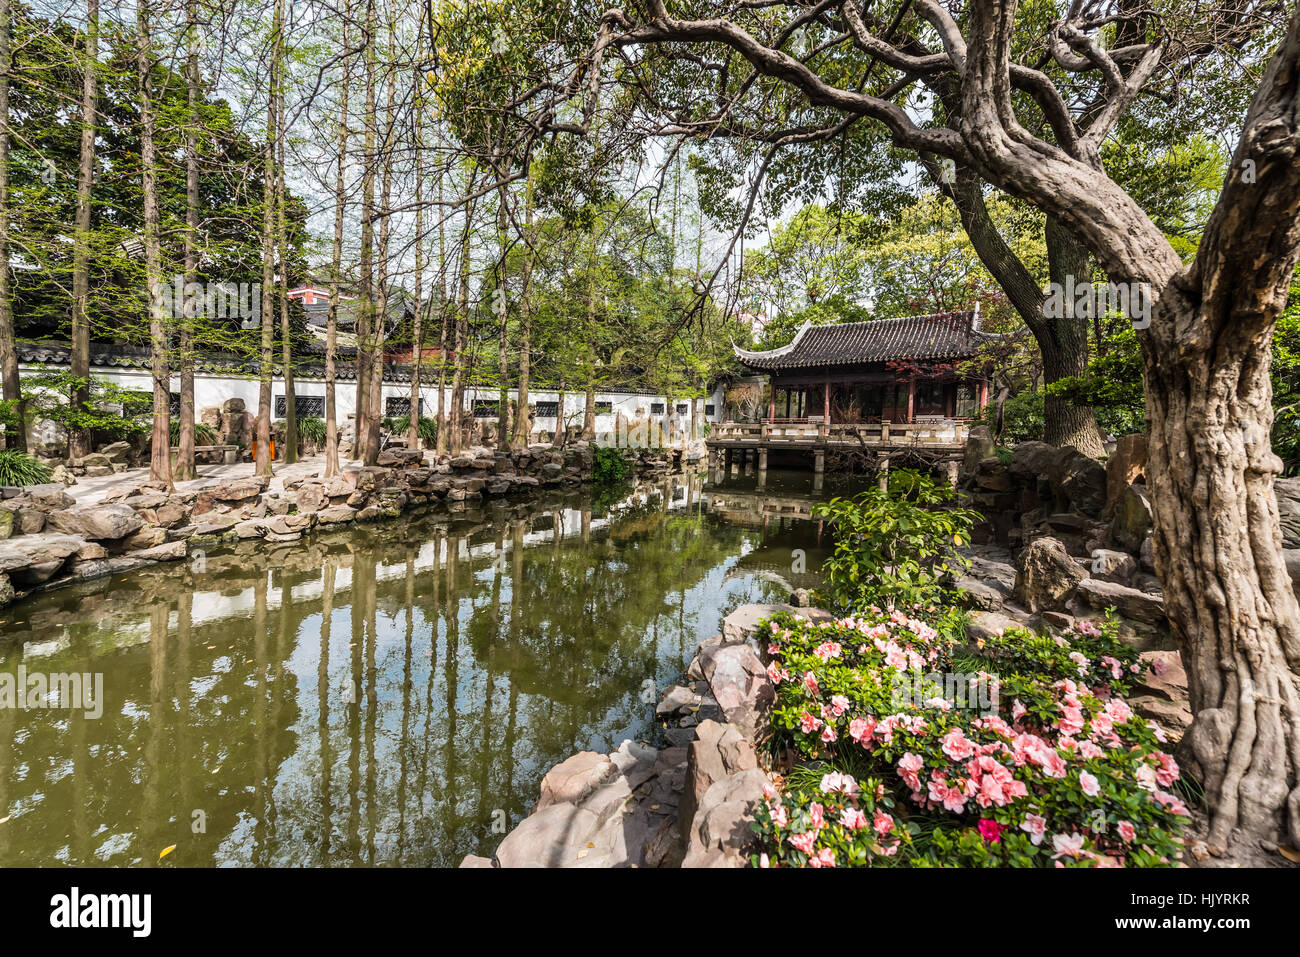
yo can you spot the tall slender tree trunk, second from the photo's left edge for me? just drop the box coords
[68,0,99,459]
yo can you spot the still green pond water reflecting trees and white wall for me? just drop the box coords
[0,473,829,866]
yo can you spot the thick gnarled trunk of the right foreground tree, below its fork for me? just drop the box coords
[1145,289,1300,849]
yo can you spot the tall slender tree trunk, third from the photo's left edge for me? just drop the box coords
[135,0,172,488]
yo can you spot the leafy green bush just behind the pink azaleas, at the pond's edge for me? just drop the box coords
[813,468,982,611]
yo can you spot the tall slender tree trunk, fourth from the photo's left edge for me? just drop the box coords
[172,0,202,481]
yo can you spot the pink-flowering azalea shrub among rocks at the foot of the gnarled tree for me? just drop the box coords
[755,611,1187,867]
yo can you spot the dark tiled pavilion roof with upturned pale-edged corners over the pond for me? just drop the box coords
[732,309,998,372]
